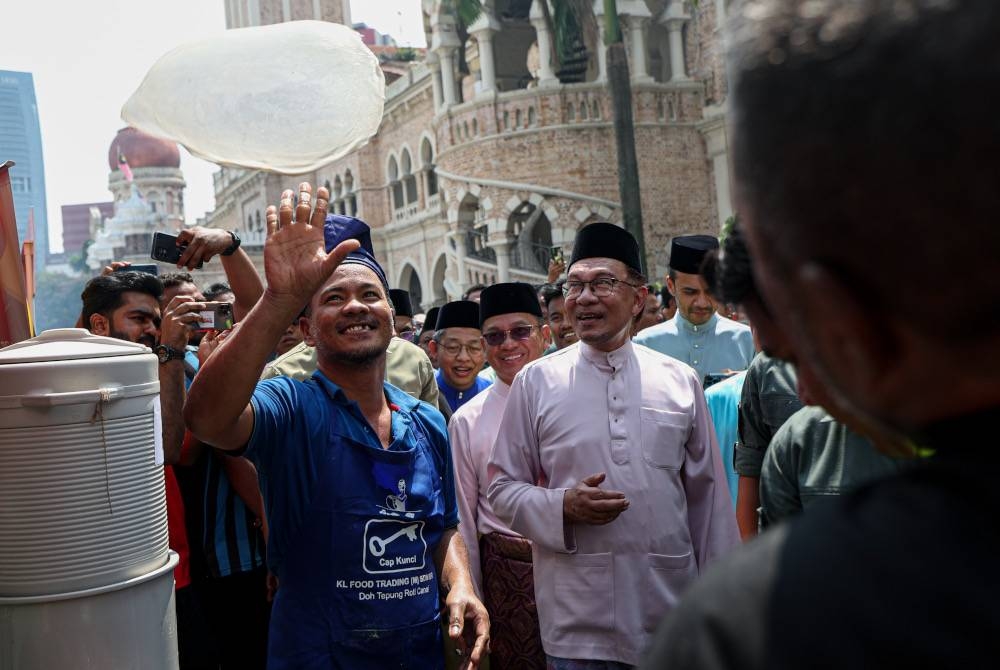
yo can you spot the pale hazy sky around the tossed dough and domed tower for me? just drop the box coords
[0,0,424,251]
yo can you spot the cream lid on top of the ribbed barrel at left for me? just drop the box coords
[0,328,152,365]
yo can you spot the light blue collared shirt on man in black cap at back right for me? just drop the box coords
[633,312,754,383]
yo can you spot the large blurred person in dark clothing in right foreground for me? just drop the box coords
[648,0,1000,670]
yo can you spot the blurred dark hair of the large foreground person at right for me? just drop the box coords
[727,0,1000,338]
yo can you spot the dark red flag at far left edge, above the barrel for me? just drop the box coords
[0,161,31,347]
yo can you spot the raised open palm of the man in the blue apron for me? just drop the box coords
[264,182,361,309]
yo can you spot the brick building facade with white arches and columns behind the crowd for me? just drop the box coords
[207,0,732,310]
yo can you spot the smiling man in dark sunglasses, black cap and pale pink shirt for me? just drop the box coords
[448,283,549,670]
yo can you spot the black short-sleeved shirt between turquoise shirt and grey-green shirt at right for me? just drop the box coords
[733,353,802,477]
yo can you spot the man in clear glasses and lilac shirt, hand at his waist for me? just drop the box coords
[487,223,739,670]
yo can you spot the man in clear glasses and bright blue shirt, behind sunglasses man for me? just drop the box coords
[430,300,492,412]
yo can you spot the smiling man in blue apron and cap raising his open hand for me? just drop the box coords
[185,183,489,669]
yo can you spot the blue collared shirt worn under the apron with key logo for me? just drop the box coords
[245,371,458,576]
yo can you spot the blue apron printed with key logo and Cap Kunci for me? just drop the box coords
[268,387,444,670]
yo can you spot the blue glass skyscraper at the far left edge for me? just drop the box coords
[0,70,49,270]
